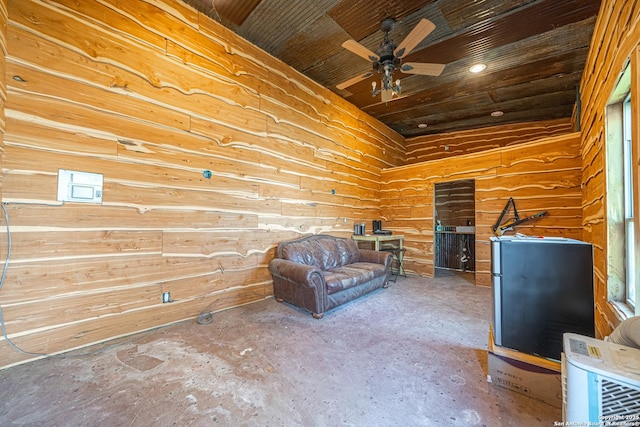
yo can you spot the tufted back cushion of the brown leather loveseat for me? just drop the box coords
[278,235,360,270]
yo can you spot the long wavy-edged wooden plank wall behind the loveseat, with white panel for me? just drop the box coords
[0,0,405,367]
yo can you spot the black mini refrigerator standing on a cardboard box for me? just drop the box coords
[491,236,595,360]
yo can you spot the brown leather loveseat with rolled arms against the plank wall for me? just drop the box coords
[269,234,391,319]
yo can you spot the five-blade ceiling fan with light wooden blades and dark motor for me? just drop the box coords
[336,18,445,102]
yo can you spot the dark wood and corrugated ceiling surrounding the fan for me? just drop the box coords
[185,0,600,137]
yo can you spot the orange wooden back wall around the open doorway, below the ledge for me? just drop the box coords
[381,133,582,286]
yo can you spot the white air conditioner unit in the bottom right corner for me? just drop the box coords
[562,333,640,426]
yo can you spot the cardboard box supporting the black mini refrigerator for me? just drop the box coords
[487,331,562,408]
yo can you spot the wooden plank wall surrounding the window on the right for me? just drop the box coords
[580,0,640,336]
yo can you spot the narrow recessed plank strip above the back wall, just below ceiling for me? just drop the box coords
[406,118,574,164]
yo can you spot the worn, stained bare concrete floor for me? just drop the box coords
[0,273,562,427]
